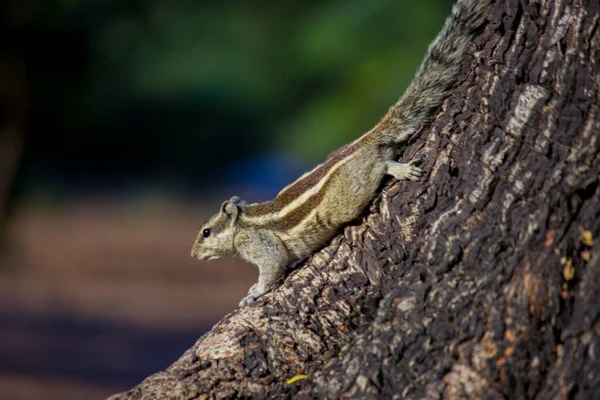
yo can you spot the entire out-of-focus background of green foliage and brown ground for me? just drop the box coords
[0,0,451,399]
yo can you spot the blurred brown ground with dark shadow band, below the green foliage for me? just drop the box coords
[0,196,257,399]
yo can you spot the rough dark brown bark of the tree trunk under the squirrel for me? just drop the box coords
[112,0,600,399]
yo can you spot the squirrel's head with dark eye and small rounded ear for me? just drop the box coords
[192,196,241,261]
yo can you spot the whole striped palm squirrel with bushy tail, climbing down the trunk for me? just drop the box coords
[191,0,492,308]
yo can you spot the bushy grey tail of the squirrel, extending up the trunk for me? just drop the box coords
[375,0,492,142]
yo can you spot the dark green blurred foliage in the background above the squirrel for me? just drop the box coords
[8,0,451,195]
